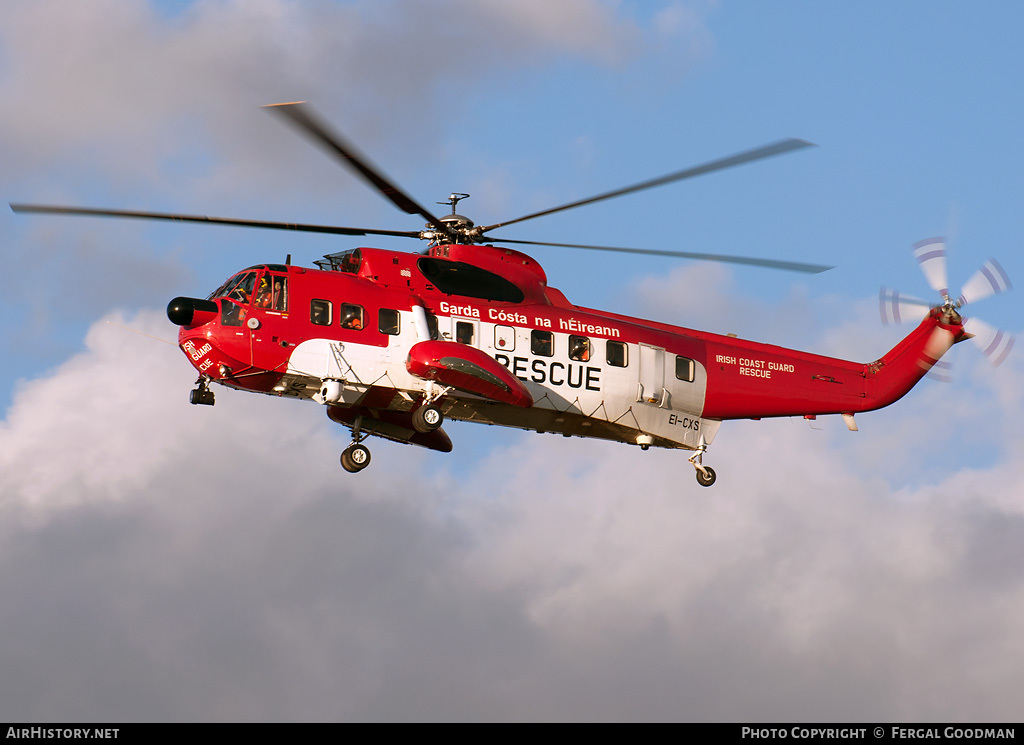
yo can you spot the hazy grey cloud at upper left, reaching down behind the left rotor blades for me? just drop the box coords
[0,0,688,395]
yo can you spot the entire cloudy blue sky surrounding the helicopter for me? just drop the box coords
[0,0,1024,721]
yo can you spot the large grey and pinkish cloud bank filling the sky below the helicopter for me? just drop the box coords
[0,304,1024,720]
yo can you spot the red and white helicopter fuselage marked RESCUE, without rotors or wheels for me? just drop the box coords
[172,246,963,449]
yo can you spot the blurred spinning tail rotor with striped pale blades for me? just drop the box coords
[879,237,1014,368]
